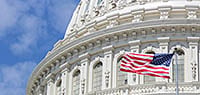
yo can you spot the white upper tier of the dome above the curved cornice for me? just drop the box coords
[65,0,199,39]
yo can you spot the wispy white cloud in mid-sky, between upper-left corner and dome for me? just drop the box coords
[11,15,46,55]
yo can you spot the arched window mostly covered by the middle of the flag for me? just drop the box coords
[144,50,156,84]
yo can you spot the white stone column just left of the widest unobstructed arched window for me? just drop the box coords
[79,53,90,95]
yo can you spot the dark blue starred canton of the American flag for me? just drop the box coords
[150,54,174,66]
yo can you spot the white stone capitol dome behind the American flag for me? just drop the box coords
[26,0,200,95]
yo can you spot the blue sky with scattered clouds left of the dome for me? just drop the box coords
[0,0,79,95]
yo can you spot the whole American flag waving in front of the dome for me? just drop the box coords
[120,53,173,78]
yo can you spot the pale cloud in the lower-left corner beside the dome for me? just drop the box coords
[0,62,36,95]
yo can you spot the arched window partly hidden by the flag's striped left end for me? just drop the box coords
[117,57,128,87]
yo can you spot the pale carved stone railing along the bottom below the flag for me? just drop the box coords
[87,82,200,95]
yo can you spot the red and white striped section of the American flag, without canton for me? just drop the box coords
[120,53,172,78]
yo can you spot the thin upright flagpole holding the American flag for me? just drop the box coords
[174,48,179,95]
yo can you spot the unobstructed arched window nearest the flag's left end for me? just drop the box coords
[92,62,103,91]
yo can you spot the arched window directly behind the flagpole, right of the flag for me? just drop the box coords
[172,49,185,82]
